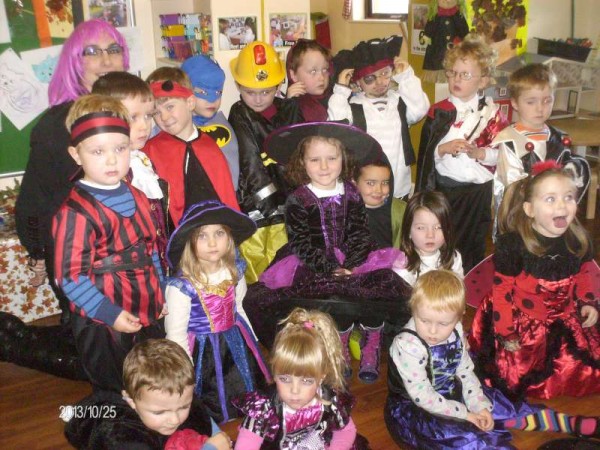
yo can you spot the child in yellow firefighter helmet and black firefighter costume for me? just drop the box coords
[229,41,301,283]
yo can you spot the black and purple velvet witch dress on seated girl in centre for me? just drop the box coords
[244,182,411,348]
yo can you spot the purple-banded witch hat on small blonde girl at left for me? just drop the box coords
[167,200,256,269]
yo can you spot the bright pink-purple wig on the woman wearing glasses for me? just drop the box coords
[48,19,129,106]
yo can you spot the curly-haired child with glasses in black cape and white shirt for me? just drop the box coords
[416,34,508,273]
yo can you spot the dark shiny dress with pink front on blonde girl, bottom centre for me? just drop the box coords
[233,387,369,450]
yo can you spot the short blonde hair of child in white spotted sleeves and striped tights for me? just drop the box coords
[408,270,466,315]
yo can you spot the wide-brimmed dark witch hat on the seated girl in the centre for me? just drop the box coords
[264,122,389,170]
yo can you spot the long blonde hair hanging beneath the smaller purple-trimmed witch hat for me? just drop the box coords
[179,224,239,284]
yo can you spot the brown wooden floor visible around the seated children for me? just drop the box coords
[0,205,600,450]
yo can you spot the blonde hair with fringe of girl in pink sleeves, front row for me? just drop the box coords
[271,308,346,391]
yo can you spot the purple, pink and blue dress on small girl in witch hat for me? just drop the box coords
[168,278,271,423]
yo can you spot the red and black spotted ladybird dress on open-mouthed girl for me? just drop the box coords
[469,233,600,398]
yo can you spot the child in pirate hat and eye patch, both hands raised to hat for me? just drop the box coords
[328,36,429,199]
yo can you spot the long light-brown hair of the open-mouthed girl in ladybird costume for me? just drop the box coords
[498,168,592,258]
